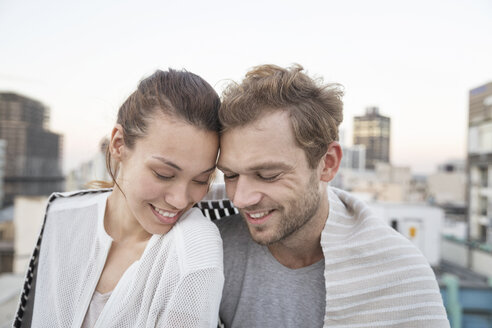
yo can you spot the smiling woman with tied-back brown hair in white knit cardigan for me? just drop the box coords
[15,70,224,328]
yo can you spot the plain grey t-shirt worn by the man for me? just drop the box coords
[216,214,326,328]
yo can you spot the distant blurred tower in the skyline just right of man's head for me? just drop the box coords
[353,107,390,170]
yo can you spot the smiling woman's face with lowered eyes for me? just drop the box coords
[113,113,219,234]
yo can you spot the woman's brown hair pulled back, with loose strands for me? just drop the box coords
[90,69,220,187]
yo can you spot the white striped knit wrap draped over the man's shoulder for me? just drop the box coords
[202,185,449,328]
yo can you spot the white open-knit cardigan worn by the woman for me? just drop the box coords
[26,192,224,328]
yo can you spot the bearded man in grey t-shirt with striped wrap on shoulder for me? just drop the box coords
[217,65,449,328]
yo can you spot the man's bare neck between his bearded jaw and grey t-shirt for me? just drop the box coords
[268,195,329,269]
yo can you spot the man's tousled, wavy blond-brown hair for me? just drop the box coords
[219,64,343,168]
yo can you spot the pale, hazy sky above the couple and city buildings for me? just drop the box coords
[0,0,492,174]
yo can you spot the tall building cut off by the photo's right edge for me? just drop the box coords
[467,82,492,243]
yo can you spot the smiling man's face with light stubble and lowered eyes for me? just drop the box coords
[218,111,321,245]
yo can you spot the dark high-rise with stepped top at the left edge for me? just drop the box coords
[0,93,63,206]
